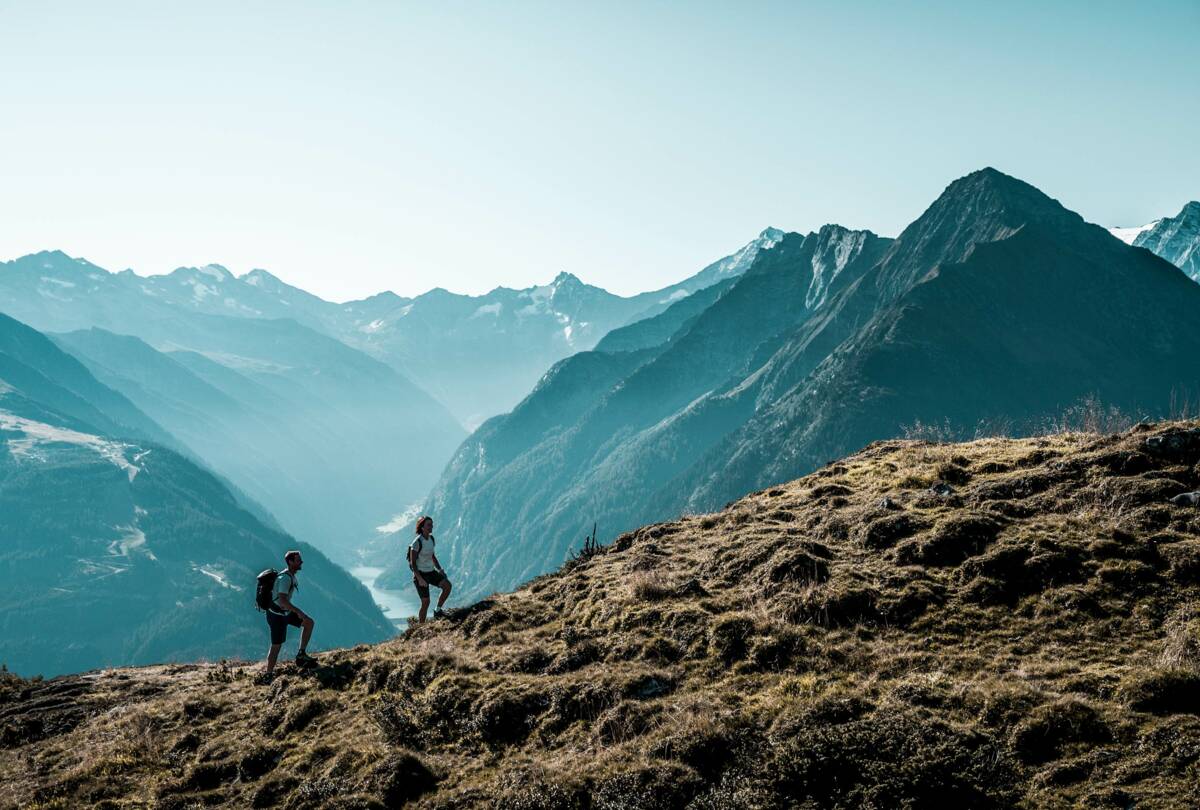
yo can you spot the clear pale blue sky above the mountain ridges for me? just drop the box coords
[0,0,1200,301]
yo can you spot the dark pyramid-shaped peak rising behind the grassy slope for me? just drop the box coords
[676,170,1200,509]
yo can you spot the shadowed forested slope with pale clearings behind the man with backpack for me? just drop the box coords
[0,323,390,674]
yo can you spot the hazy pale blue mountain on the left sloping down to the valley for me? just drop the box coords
[0,251,464,560]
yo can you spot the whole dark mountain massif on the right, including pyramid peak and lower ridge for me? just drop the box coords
[417,169,1200,602]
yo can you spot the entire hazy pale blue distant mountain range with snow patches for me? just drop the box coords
[0,228,781,563]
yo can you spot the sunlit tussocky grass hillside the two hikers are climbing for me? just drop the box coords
[0,422,1200,809]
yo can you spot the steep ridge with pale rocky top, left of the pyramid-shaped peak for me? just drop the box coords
[427,226,889,593]
